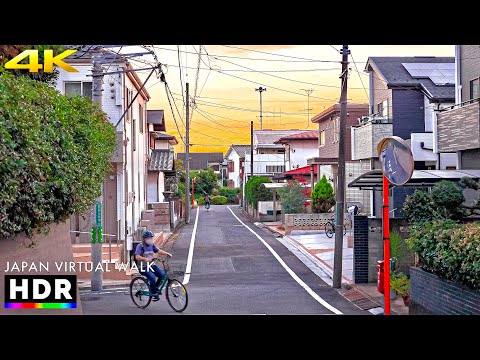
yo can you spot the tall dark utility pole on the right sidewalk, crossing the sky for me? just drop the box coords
[333,45,350,289]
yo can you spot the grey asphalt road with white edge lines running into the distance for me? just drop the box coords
[81,205,365,315]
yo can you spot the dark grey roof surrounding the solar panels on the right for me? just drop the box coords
[366,56,455,100]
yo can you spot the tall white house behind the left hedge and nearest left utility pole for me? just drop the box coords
[56,50,150,256]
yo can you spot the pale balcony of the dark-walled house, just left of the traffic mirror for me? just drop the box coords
[351,114,393,160]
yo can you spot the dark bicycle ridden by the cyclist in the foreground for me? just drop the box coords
[130,258,188,312]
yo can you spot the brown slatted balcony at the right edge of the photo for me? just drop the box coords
[437,99,480,152]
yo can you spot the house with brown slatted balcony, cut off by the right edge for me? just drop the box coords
[434,45,480,169]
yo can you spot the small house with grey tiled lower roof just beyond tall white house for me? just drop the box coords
[147,110,178,204]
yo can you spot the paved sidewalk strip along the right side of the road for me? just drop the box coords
[263,228,408,315]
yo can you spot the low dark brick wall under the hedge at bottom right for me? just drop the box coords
[409,267,480,315]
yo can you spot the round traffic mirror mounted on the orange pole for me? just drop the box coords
[377,136,414,185]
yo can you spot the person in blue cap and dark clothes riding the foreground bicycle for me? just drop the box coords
[135,230,172,301]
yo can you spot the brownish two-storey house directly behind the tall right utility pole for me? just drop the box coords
[307,104,370,213]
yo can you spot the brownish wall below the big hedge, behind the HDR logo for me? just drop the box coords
[0,221,82,315]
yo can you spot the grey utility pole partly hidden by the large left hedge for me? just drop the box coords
[90,47,103,291]
